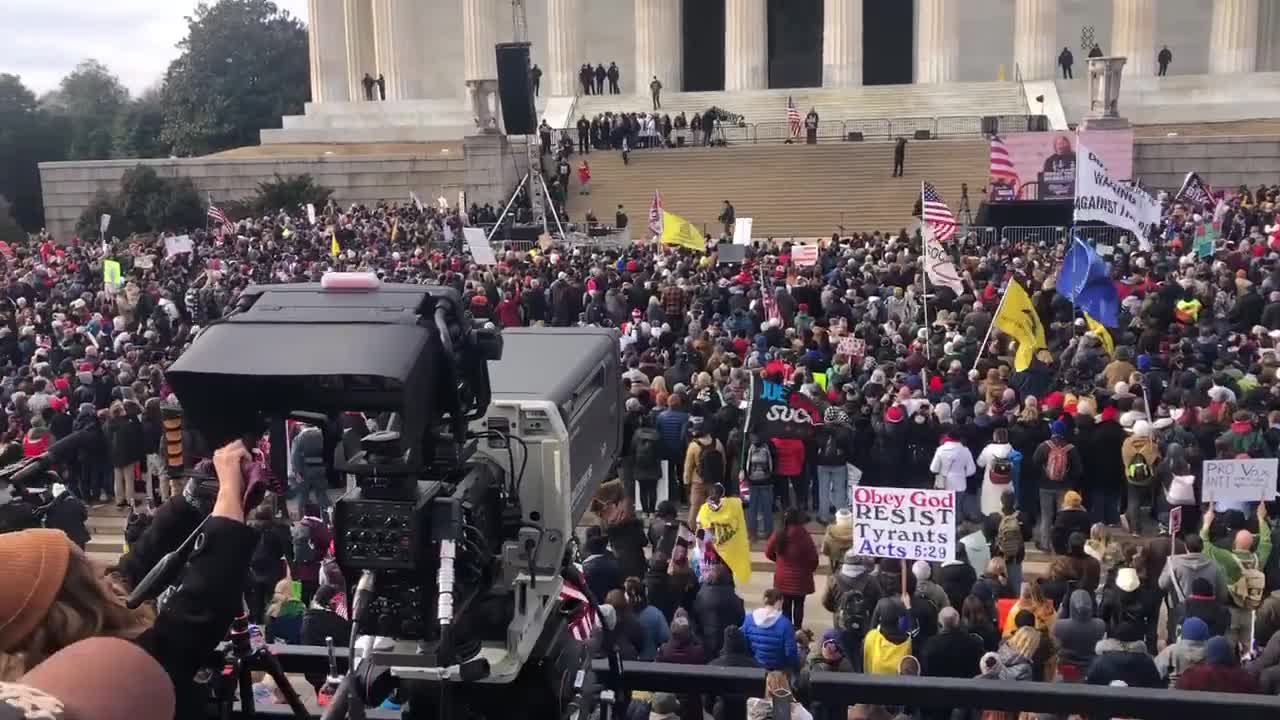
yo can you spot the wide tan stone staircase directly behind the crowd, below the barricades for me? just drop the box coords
[568,138,989,240]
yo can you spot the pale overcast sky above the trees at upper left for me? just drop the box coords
[0,0,312,95]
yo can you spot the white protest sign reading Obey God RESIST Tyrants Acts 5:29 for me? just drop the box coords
[852,486,956,562]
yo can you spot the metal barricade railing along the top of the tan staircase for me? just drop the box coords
[557,115,1039,149]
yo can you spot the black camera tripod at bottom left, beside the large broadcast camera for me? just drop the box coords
[197,612,311,720]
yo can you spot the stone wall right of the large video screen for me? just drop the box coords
[1133,136,1280,191]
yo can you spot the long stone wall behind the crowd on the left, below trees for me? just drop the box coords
[40,149,504,238]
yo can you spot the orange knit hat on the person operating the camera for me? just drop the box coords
[0,529,72,652]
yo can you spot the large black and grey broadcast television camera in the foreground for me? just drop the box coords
[168,274,622,717]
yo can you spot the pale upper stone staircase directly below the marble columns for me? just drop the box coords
[573,82,1027,124]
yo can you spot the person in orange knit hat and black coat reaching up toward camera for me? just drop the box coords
[0,441,257,717]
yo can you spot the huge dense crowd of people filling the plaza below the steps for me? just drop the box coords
[0,176,1280,720]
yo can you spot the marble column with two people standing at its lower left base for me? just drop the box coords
[374,0,430,100]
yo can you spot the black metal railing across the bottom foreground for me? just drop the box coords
[257,646,1280,720]
